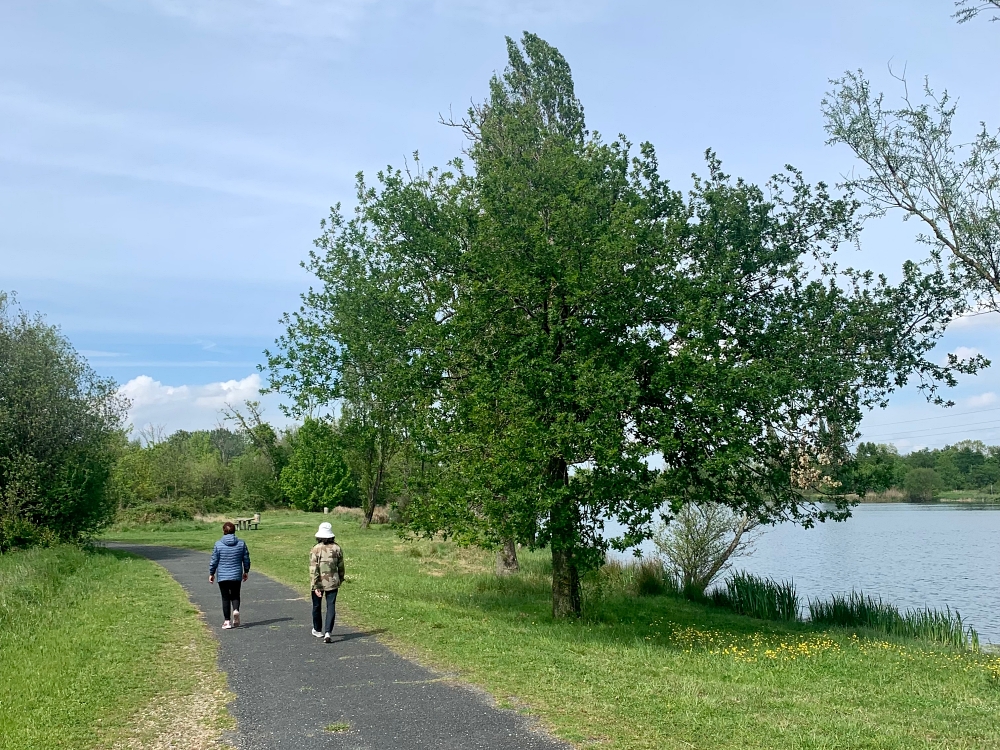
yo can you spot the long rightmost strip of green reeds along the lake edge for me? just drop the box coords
[809,591,979,651]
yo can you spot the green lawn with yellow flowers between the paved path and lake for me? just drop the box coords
[105,513,1000,750]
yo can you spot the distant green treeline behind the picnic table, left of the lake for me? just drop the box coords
[110,412,424,523]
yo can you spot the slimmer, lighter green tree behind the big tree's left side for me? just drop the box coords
[265,187,439,526]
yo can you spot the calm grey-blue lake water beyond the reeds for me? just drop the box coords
[608,503,1000,643]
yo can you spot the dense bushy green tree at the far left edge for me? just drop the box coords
[0,293,127,549]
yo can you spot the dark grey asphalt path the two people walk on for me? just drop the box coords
[108,544,568,750]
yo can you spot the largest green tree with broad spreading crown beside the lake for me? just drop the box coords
[271,34,976,616]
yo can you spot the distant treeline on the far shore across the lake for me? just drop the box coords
[840,440,1000,501]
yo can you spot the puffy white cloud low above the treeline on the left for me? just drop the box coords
[119,373,283,434]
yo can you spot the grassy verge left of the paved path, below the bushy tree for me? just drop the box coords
[0,546,226,750]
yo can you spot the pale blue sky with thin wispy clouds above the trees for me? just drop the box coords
[0,0,1000,450]
